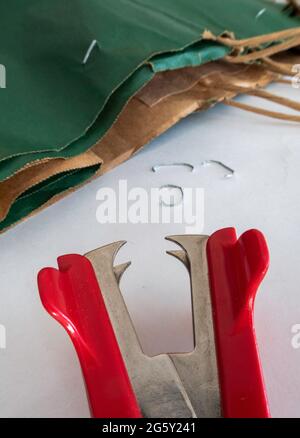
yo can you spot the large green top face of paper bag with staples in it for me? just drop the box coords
[0,0,298,171]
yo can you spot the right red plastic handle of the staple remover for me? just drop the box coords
[207,228,270,418]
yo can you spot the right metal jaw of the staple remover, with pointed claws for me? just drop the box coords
[166,235,220,418]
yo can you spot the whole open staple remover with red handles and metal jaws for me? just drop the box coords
[39,228,269,418]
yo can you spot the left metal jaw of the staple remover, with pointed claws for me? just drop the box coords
[86,242,196,418]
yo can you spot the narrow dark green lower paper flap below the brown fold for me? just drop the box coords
[0,165,100,231]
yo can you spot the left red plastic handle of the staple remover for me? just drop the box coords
[38,255,141,418]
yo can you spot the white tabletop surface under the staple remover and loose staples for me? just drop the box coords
[0,86,300,417]
